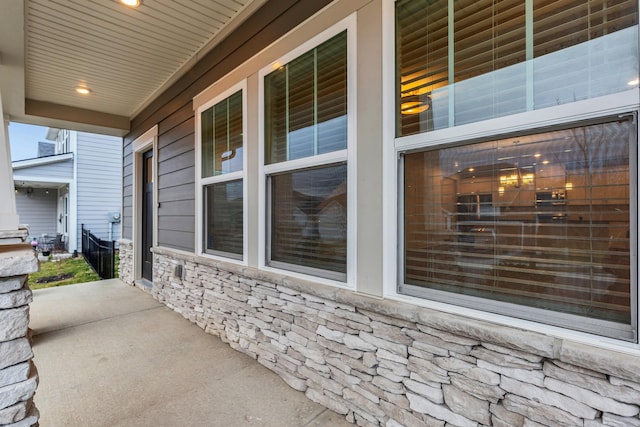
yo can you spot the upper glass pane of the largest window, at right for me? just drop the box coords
[396,0,638,136]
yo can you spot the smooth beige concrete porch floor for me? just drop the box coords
[30,279,351,427]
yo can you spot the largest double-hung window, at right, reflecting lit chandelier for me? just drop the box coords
[395,0,639,341]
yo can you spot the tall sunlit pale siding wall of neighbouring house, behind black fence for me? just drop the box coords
[76,132,122,249]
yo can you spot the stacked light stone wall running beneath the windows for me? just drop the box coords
[135,248,640,427]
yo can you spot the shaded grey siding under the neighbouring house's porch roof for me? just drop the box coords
[16,188,58,237]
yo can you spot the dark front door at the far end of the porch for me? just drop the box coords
[142,150,153,281]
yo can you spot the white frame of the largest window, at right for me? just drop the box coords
[382,0,640,348]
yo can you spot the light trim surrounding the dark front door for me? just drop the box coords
[131,125,158,280]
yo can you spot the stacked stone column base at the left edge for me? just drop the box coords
[0,229,39,427]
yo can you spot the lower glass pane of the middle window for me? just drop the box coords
[270,164,347,273]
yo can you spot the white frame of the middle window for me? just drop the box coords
[258,13,357,289]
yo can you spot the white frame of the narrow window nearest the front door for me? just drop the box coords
[195,79,249,265]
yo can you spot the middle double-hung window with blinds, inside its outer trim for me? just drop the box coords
[261,25,351,282]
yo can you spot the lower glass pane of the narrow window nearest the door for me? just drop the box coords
[204,179,243,255]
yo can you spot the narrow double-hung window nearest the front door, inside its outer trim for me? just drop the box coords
[197,86,245,260]
